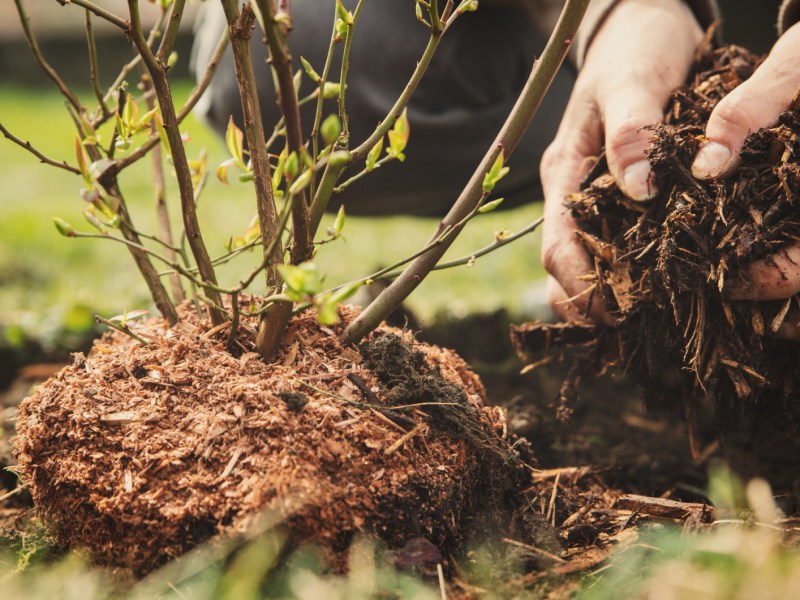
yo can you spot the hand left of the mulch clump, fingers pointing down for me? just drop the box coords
[540,0,703,324]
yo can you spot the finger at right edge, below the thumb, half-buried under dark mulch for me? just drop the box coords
[723,242,800,300]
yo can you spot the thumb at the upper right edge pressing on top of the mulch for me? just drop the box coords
[692,25,800,179]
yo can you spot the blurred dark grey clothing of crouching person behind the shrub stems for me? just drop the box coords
[199,0,575,215]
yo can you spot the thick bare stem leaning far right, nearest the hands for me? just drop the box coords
[341,0,589,343]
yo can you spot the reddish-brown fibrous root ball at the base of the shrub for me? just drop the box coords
[10,307,526,574]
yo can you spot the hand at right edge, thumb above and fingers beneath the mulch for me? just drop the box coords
[692,23,800,341]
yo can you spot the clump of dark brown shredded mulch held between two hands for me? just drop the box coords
[513,46,800,460]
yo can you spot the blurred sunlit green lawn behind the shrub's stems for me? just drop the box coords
[0,83,543,344]
